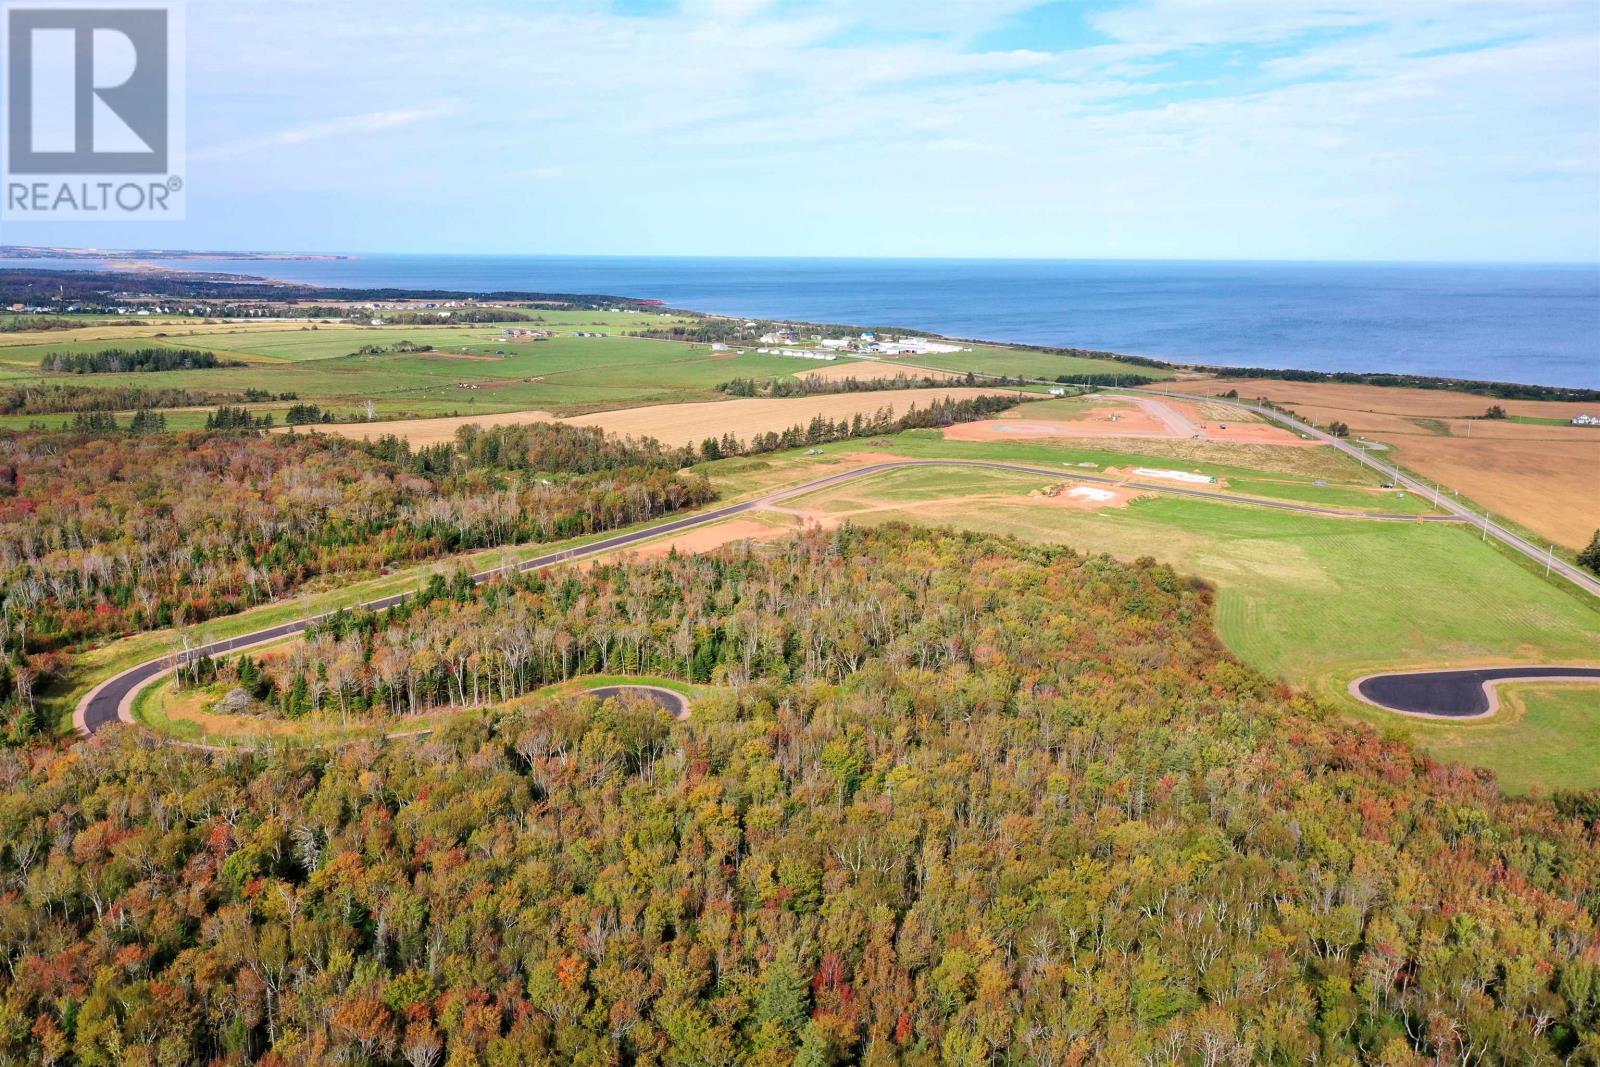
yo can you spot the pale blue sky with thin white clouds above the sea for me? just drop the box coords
[0,0,1600,262]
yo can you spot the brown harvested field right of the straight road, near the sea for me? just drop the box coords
[1162,379,1600,549]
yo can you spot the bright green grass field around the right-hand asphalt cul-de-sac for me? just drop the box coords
[764,469,1600,790]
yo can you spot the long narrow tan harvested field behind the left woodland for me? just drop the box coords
[296,387,1010,446]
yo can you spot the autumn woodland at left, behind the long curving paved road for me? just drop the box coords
[0,427,715,741]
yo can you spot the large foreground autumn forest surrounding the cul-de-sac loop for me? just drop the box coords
[0,526,1600,1067]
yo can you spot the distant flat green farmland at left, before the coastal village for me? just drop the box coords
[0,309,1164,429]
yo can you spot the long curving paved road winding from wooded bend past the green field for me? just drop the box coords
[74,459,1461,734]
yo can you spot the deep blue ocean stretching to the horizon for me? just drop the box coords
[0,256,1600,387]
